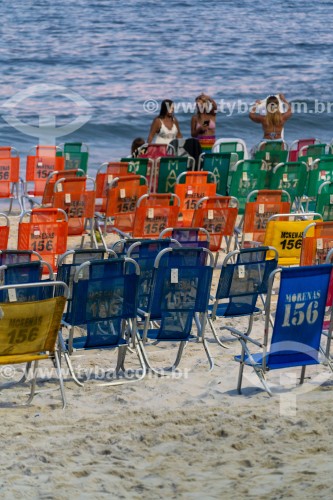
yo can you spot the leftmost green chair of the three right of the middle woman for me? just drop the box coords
[200,153,239,196]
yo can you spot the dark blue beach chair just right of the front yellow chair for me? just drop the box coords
[60,258,146,386]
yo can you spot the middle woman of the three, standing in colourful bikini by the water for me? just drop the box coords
[191,94,217,153]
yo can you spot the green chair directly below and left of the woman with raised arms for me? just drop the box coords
[229,160,267,215]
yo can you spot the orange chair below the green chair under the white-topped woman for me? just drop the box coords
[132,193,180,238]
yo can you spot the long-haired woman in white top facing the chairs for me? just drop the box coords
[147,99,183,144]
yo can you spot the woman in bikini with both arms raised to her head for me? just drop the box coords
[249,94,292,145]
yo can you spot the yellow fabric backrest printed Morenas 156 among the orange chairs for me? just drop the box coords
[264,220,313,266]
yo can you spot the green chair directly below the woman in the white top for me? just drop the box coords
[153,156,194,193]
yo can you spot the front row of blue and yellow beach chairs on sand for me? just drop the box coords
[0,240,333,405]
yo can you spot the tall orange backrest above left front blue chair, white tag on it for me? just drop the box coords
[105,175,148,232]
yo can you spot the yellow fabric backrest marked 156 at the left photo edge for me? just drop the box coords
[0,297,66,364]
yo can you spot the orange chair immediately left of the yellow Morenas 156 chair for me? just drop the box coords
[241,189,291,248]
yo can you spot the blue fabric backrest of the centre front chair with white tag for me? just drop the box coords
[148,248,214,341]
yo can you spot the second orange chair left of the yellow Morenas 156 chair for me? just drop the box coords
[192,196,238,259]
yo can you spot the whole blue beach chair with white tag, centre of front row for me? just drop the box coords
[137,248,214,375]
